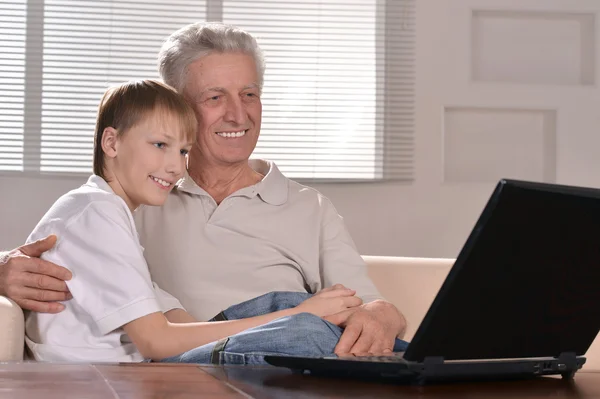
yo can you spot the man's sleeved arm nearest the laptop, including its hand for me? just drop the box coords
[319,201,406,354]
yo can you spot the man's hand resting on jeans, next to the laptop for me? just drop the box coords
[324,300,406,355]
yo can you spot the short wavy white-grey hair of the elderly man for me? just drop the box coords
[158,22,265,93]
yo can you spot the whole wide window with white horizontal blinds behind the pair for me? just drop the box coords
[0,0,415,181]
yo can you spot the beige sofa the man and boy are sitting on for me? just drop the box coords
[0,256,600,370]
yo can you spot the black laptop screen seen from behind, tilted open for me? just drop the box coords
[405,181,600,361]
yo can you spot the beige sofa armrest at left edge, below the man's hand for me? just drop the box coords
[0,296,25,362]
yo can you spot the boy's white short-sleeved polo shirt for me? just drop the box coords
[25,176,182,362]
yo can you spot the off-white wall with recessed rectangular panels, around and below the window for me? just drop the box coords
[0,0,600,257]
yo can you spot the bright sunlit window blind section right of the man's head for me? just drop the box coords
[223,0,414,180]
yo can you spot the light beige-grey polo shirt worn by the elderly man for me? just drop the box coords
[134,160,381,320]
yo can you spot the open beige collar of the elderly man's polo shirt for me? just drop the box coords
[177,159,288,206]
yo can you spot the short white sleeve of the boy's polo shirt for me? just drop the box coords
[48,201,161,334]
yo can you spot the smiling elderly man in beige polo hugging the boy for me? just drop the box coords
[0,24,406,360]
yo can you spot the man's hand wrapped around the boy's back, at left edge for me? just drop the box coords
[0,235,72,313]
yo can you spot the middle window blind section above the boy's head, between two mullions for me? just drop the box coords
[40,0,205,173]
